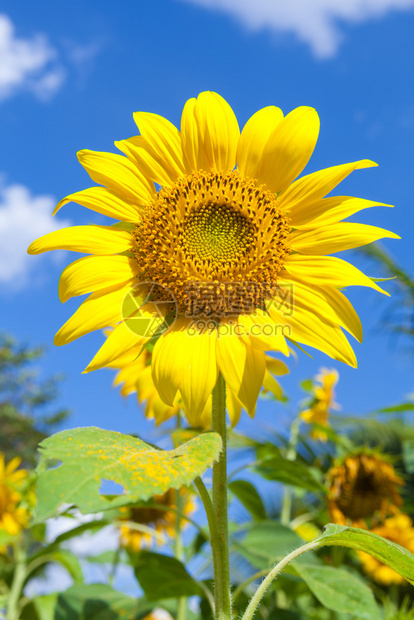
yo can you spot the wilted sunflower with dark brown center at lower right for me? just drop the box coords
[328,453,404,527]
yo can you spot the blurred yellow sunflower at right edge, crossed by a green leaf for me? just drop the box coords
[357,512,414,586]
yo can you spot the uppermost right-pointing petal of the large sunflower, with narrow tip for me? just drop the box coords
[280,159,377,217]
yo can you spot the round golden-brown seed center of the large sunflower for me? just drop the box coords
[133,171,290,320]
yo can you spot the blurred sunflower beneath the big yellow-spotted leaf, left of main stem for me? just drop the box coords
[120,489,196,551]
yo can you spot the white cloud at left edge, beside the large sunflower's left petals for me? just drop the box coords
[0,178,70,289]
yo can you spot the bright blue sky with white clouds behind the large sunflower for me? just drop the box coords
[0,0,414,437]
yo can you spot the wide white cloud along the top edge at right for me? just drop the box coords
[183,0,414,58]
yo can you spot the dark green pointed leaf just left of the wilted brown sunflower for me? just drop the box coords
[254,455,326,493]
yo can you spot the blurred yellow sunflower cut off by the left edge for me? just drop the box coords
[0,454,29,536]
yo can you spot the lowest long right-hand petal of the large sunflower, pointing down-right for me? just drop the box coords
[267,302,357,368]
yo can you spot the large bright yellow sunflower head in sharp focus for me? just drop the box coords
[28,92,398,418]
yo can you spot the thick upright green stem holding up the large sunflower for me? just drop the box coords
[212,373,231,620]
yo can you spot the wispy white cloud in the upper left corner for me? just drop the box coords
[0,14,65,101]
